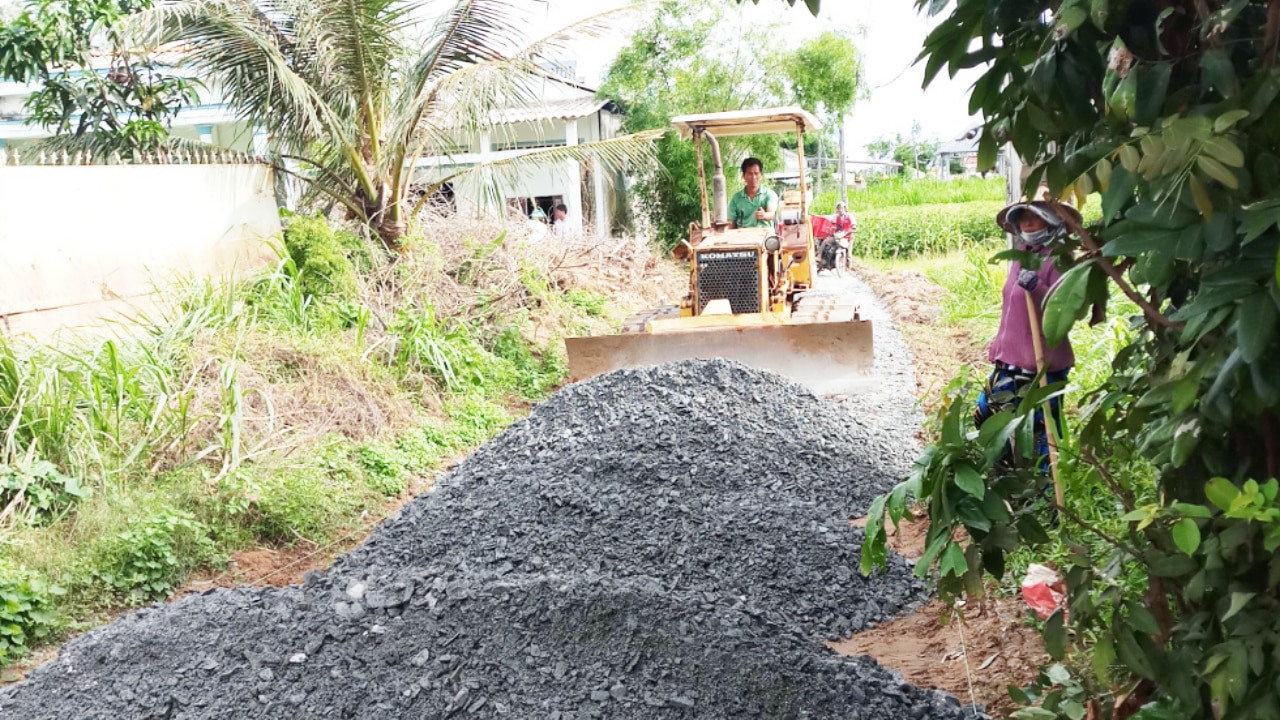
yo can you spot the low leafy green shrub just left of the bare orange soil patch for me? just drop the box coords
[93,510,216,605]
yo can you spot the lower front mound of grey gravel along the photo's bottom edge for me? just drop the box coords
[0,575,965,720]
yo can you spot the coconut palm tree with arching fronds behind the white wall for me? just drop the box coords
[137,0,654,249]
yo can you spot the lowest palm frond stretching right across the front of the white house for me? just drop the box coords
[410,129,666,218]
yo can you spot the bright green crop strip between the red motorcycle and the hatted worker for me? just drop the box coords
[854,201,1005,258]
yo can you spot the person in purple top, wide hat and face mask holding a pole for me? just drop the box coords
[974,201,1080,470]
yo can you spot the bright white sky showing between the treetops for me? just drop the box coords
[524,0,980,159]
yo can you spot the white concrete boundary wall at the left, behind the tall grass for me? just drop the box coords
[0,164,280,337]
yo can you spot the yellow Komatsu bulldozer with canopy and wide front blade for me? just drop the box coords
[564,108,873,395]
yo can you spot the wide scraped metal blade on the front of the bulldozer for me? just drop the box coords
[564,320,873,395]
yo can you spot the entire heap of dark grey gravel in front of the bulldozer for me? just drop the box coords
[0,361,966,720]
